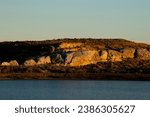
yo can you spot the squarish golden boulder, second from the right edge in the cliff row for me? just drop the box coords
[122,48,135,59]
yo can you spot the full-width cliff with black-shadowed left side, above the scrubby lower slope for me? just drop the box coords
[0,39,150,66]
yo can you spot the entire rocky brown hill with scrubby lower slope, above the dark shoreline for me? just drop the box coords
[0,39,150,79]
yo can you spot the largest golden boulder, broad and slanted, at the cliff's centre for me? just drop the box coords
[66,50,99,66]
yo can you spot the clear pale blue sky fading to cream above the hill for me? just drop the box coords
[0,0,150,43]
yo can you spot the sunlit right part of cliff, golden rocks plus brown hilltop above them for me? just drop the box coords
[59,39,150,66]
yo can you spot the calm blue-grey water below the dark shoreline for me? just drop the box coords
[0,80,150,100]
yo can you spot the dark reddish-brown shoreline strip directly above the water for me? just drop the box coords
[0,73,150,81]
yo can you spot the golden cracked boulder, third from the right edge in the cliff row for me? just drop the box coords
[108,50,122,62]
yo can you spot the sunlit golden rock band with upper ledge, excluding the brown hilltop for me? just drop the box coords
[59,42,150,66]
